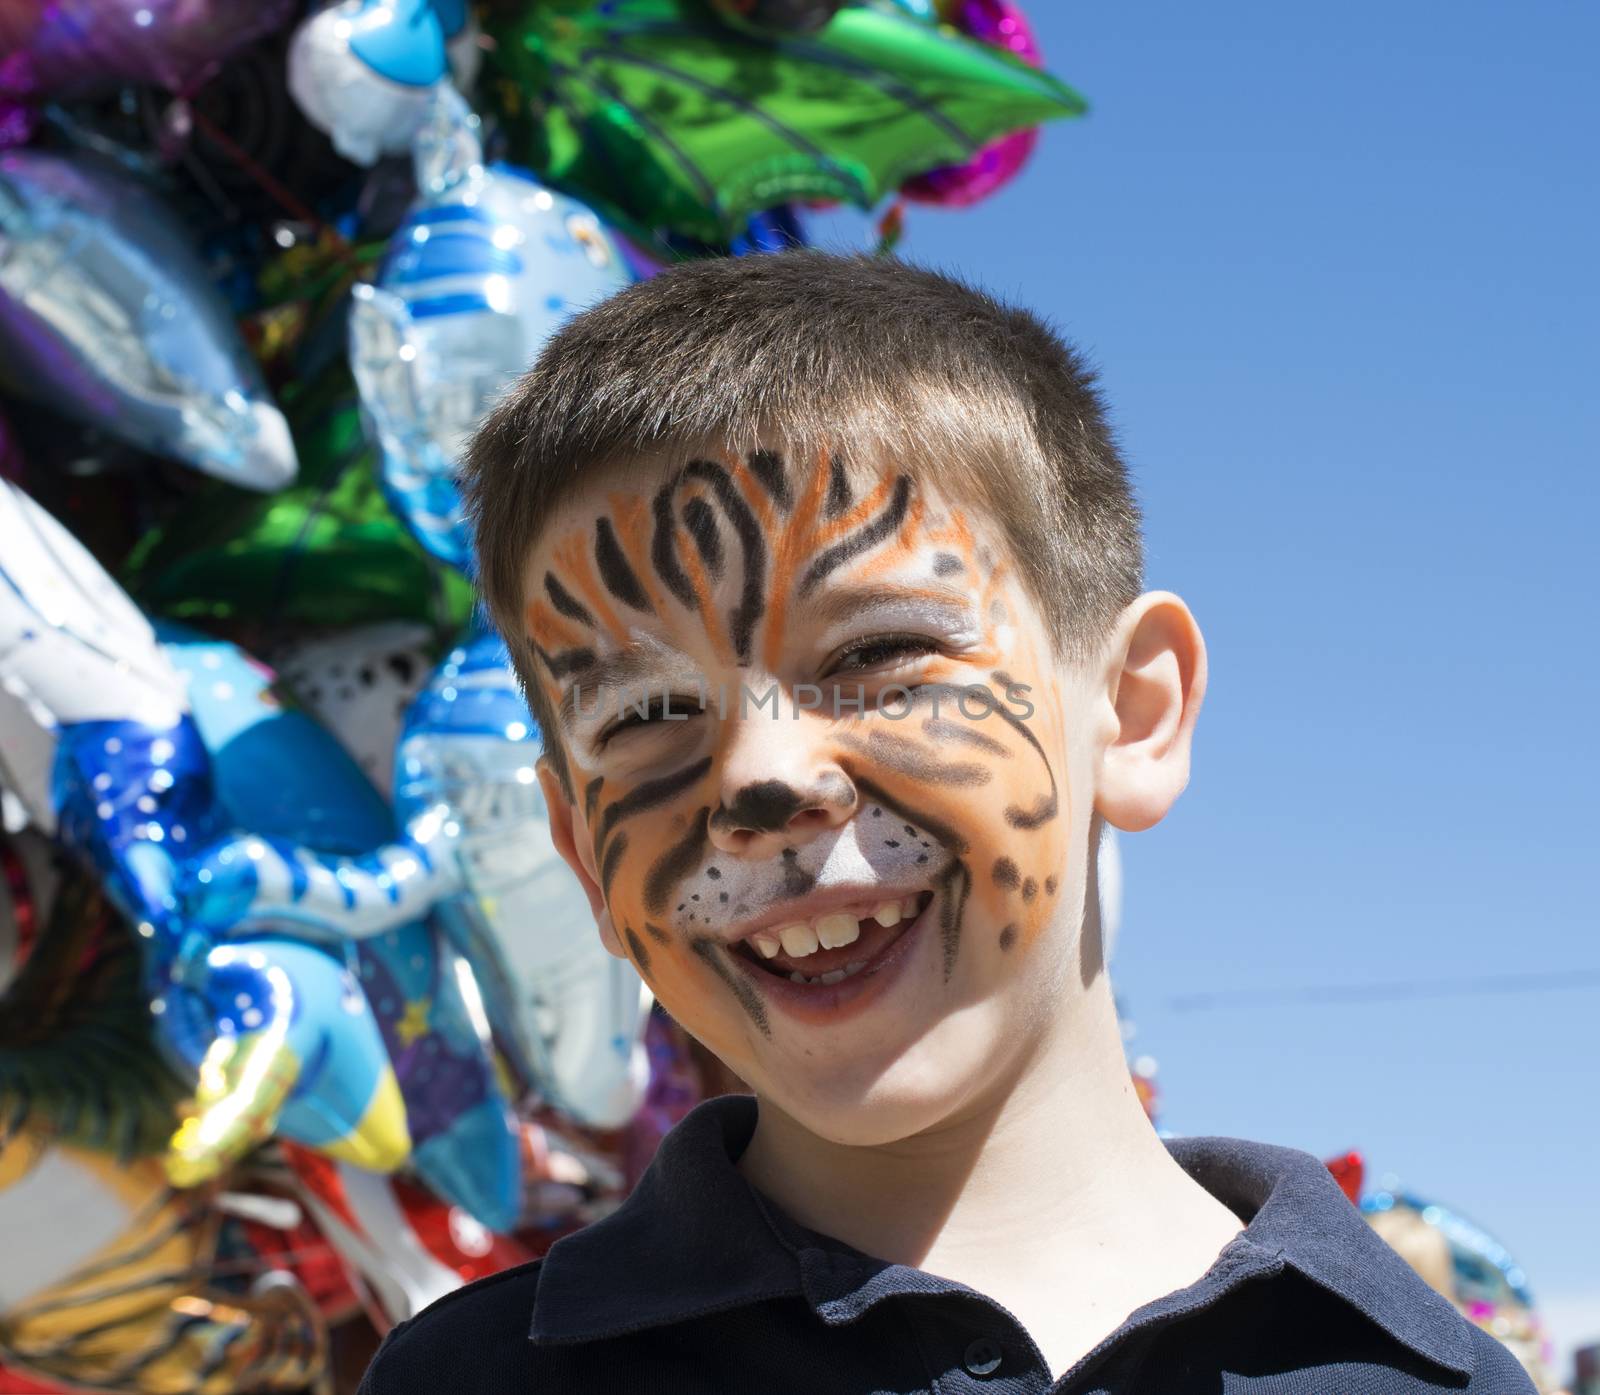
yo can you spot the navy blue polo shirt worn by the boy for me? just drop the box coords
[360,1096,1533,1395]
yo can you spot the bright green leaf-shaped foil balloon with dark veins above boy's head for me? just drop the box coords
[483,0,1086,243]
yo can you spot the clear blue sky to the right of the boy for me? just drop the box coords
[813,0,1600,1375]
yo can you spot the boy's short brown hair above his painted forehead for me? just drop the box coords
[464,250,1142,774]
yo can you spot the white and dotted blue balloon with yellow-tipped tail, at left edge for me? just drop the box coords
[0,483,410,1184]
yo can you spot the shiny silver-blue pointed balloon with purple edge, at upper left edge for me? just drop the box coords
[0,150,296,490]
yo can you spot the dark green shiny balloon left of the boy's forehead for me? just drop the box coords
[125,366,472,635]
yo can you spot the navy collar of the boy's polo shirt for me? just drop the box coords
[530,1094,1472,1374]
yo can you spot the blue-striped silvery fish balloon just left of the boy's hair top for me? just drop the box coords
[350,91,632,570]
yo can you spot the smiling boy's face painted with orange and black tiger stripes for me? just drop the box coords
[523,453,1091,1144]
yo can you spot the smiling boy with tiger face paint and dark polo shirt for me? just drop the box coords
[363,251,1531,1395]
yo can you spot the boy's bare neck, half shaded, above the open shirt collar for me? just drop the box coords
[738,974,1240,1365]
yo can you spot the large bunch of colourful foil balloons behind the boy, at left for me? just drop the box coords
[0,0,1083,1392]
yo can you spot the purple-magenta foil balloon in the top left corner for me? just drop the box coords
[0,0,296,112]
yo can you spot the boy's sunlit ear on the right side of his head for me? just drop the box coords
[1094,590,1206,833]
